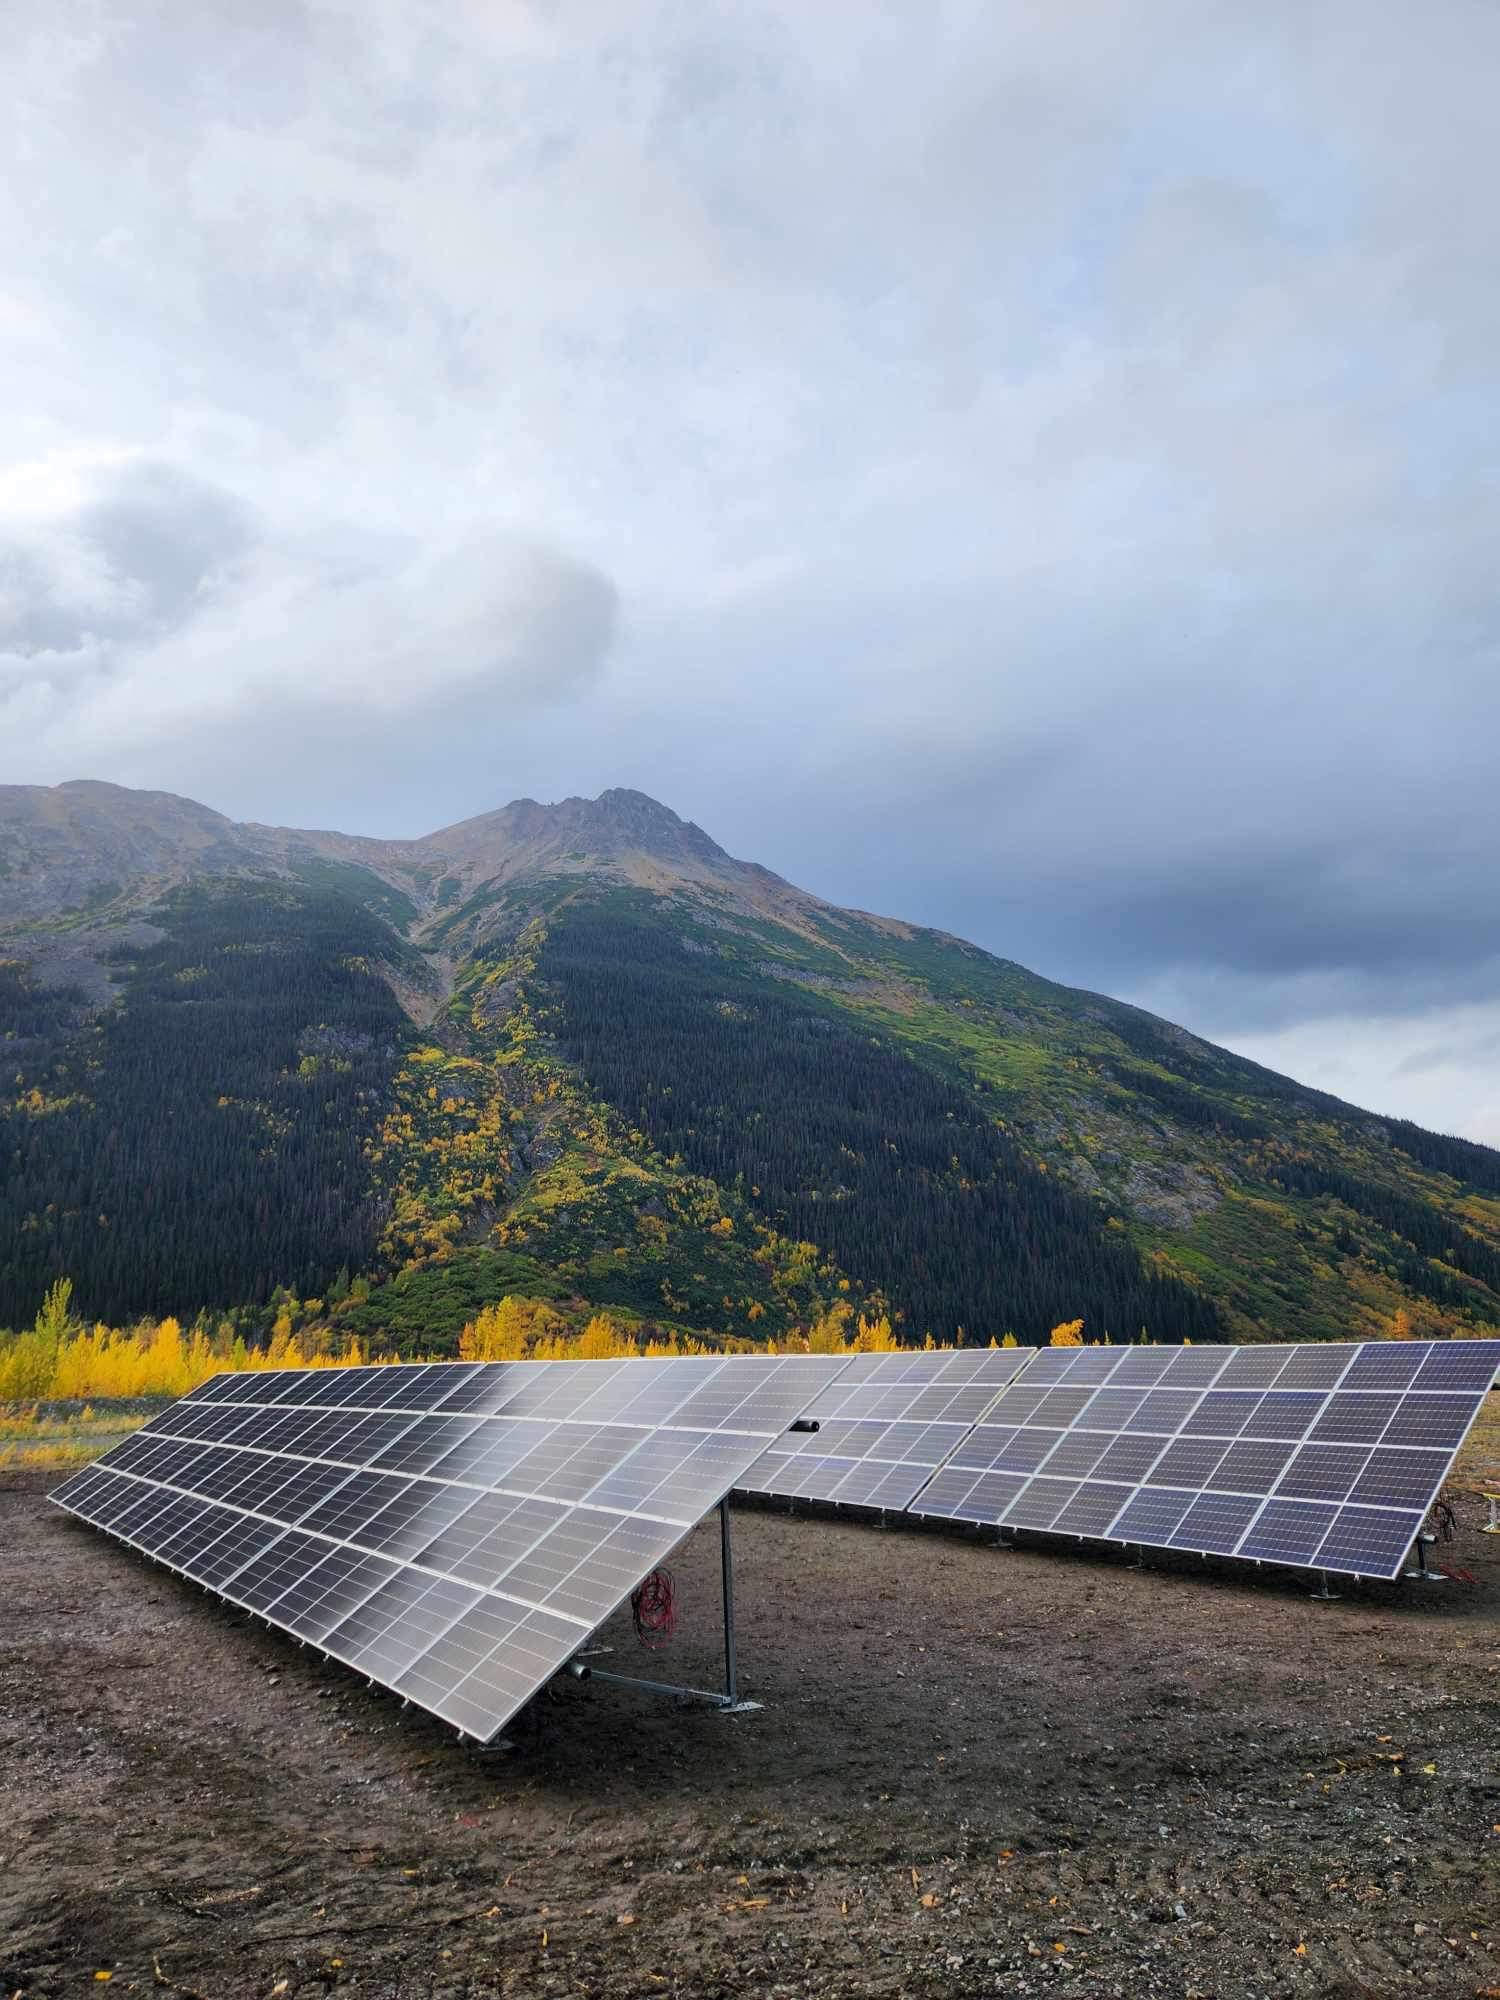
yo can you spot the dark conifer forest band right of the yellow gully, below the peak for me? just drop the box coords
[538,902,1218,1340]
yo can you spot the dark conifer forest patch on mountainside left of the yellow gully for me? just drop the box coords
[0,884,406,1326]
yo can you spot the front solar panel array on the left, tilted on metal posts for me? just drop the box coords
[52,1356,848,1742]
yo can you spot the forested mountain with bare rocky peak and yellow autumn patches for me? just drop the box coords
[0,782,1500,1346]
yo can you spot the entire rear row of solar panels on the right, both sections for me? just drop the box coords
[742,1342,1500,1576]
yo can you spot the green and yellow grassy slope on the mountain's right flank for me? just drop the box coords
[788,908,1500,1338]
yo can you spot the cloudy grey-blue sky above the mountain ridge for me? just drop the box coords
[0,0,1500,1144]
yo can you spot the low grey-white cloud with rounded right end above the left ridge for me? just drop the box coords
[0,462,616,796]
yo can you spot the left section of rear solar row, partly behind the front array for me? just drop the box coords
[738,1348,1034,1508]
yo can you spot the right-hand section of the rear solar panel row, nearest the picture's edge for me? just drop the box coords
[912,1340,1500,1576]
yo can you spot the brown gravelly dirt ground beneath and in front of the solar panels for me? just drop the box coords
[0,1472,1500,2000]
